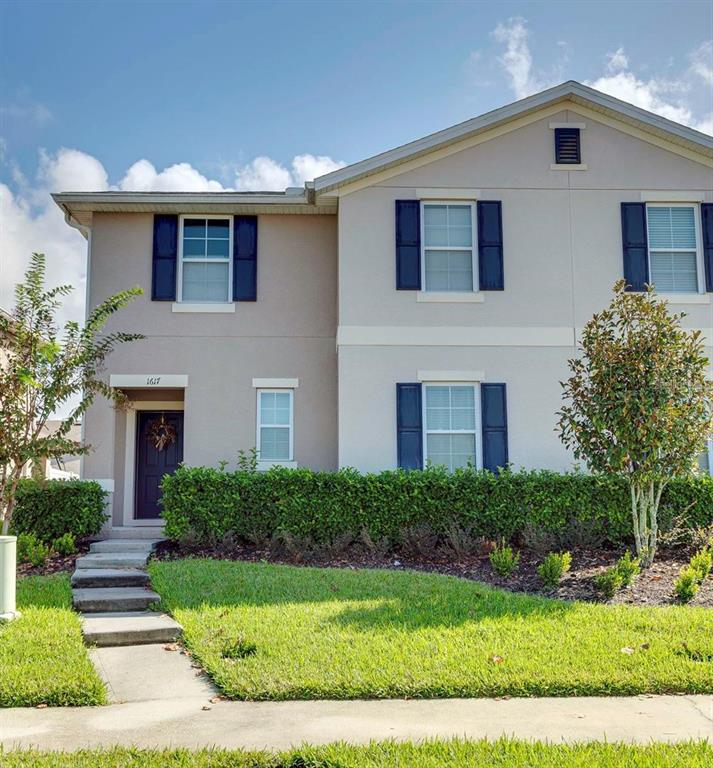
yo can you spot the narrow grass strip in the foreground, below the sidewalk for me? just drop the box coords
[0,740,713,768]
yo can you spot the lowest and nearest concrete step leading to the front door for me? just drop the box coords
[82,611,183,648]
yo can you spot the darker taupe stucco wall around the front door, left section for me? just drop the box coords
[83,214,337,523]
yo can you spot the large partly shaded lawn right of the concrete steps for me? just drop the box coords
[150,559,713,700]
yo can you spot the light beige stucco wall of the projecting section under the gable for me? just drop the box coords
[339,110,713,470]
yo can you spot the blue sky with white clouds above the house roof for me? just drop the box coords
[0,0,713,314]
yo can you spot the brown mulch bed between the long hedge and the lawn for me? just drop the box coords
[154,541,713,608]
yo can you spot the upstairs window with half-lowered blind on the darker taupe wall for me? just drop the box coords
[178,214,233,304]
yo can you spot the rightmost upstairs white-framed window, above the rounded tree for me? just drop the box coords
[646,203,704,293]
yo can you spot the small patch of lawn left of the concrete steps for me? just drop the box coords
[0,575,106,707]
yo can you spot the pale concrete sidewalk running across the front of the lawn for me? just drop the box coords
[0,691,713,750]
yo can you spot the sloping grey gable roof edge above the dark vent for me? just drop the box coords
[310,80,713,194]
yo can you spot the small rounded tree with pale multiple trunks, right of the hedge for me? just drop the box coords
[558,280,713,567]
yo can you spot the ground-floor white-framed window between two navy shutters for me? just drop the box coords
[422,382,483,472]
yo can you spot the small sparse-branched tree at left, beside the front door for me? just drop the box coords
[0,253,143,535]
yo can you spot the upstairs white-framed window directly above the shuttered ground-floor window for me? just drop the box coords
[421,201,478,293]
